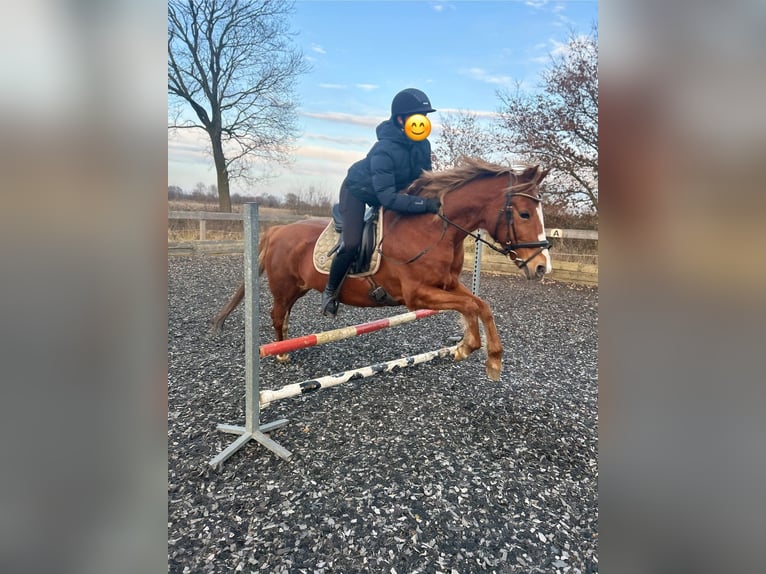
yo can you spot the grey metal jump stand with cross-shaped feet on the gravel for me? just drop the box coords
[210,203,293,468]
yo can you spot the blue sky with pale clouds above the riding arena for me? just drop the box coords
[168,0,598,197]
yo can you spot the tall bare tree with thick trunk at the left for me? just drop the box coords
[168,0,308,211]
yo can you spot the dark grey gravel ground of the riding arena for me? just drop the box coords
[168,256,598,574]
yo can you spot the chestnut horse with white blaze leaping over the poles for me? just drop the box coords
[212,158,551,380]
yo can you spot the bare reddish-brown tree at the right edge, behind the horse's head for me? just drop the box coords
[498,28,598,212]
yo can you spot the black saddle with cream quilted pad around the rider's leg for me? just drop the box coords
[314,203,383,277]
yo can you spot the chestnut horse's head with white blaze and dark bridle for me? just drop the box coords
[493,165,551,279]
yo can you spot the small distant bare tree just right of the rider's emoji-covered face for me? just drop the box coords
[432,110,495,170]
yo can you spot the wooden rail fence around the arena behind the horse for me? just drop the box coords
[168,211,598,285]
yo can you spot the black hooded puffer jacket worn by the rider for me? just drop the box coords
[345,120,431,213]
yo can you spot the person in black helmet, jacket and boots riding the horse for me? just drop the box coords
[322,88,441,317]
